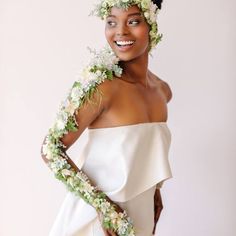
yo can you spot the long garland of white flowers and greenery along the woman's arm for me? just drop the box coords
[42,47,135,236]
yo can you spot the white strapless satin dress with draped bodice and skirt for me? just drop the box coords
[49,122,172,236]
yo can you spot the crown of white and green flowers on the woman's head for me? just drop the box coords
[92,0,163,50]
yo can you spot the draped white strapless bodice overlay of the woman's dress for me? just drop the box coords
[82,122,172,202]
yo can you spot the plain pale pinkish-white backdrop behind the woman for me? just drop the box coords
[0,0,236,236]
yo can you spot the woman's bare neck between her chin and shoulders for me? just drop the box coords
[120,50,148,86]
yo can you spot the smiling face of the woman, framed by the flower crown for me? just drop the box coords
[105,6,149,61]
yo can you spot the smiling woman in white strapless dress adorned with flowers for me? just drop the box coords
[42,0,172,236]
